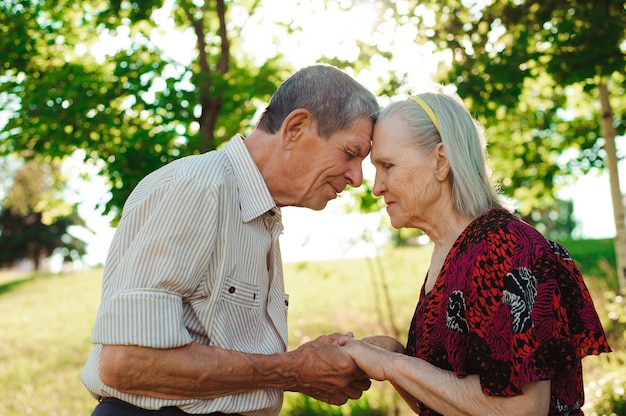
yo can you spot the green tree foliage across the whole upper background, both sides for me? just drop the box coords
[0,0,626,234]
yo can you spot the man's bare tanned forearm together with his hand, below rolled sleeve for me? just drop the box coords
[100,334,370,404]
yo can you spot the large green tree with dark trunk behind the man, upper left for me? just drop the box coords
[0,0,290,223]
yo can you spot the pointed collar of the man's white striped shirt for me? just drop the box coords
[224,134,280,222]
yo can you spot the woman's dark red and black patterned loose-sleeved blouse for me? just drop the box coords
[407,209,611,416]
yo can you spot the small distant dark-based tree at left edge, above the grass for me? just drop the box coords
[0,162,86,270]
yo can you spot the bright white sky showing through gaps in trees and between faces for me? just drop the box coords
[17,0,626,264]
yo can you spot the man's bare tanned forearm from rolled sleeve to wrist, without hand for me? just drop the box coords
[100,343,310,400]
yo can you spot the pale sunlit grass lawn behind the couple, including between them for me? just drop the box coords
[0,242,616,416]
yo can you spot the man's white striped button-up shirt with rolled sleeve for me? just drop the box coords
[82,136,288,416]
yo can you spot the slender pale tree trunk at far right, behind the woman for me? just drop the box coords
[598,82,626,293]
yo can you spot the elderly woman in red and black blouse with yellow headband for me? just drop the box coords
[344,93,610,416]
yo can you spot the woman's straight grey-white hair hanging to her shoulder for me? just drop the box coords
[378,88,513,218]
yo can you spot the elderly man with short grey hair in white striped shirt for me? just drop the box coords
[82,65,378,416]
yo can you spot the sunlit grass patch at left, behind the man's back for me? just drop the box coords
[0,270,101,416]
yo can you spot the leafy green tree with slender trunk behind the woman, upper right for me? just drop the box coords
[412,0,626,290]
